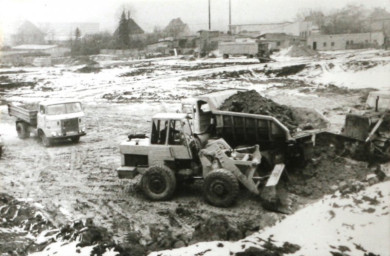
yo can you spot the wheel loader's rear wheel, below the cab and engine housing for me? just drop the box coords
[141,166,176,201]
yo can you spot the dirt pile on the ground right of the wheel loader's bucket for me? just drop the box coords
[285,135,375,199]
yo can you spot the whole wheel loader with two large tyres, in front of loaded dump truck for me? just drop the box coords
[117,113,284,207]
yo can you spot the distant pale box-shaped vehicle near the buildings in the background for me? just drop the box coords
[218,42,271,63]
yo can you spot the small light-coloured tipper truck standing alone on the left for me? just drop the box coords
[8,101,86,147]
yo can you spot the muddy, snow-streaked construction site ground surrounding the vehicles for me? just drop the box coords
[0,50,390,255]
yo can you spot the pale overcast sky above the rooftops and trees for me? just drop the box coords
[0,0,390,33]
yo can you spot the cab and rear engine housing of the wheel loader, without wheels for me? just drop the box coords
[117,113,197,178]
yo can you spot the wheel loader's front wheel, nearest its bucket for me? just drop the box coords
[203,169,239,207]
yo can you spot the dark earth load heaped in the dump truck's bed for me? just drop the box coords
[220,90,327,132]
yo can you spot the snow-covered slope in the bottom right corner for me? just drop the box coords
[150,181,390,256]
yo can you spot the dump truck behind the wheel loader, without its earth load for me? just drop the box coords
[182,90,316,168]
